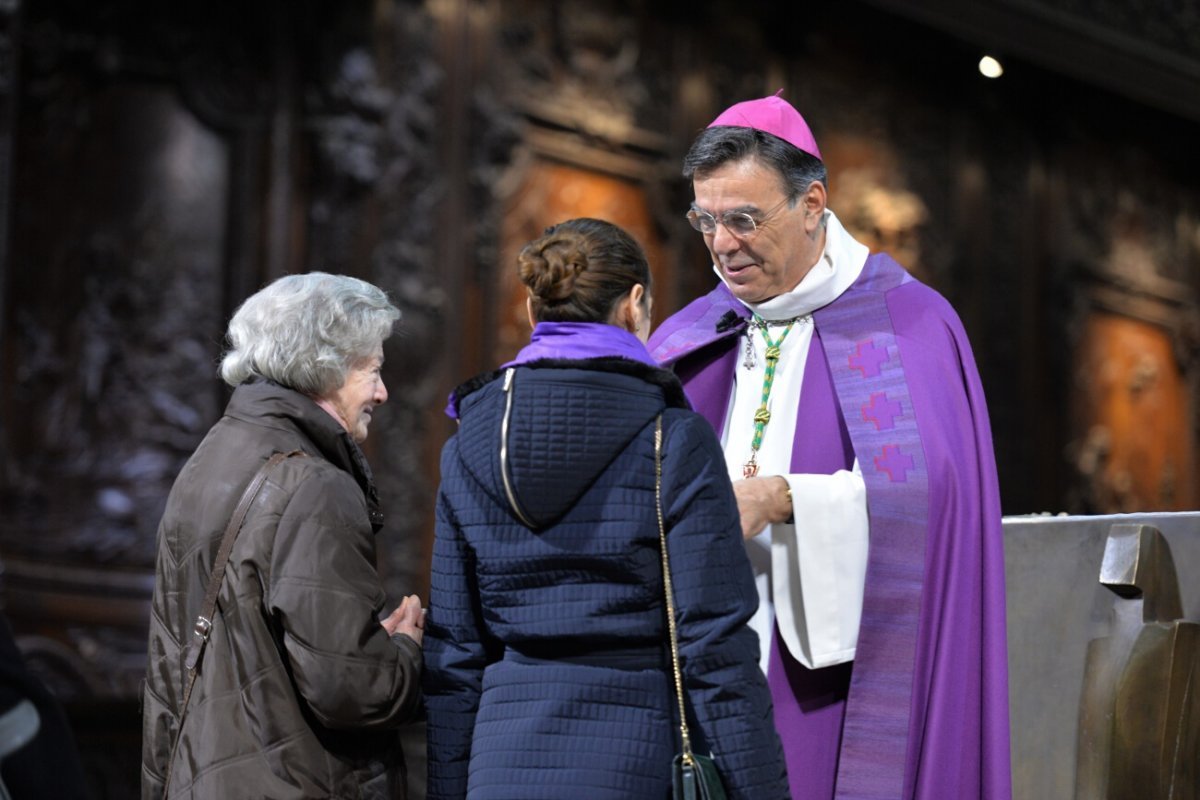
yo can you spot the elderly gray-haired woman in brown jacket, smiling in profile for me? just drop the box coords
[142,272,422,800]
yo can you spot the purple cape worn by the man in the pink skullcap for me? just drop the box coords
[650,255,1012,800]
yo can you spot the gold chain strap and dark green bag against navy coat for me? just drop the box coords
[654,414,725,800]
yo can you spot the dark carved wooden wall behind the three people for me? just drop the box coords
[0,0,1200,798]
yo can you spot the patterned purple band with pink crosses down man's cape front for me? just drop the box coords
[805,258,929,800]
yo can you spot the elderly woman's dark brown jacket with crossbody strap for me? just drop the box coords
[142,381,421,800]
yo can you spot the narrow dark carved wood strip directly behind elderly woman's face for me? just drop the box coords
[319,7,446,597]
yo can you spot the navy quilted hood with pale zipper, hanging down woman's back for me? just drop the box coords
[456,357,688,529]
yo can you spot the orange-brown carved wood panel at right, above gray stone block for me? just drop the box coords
[1063,148,1200,513]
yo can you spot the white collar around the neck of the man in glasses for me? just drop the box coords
[713,209,871,319]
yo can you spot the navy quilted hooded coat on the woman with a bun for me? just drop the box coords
[425,359,787,800]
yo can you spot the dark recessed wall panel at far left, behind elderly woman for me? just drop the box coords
[0,86,229,567]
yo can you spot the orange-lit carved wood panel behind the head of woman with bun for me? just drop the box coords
[468,0,683,368]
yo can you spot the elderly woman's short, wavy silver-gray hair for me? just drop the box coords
[221,272,400,397]
